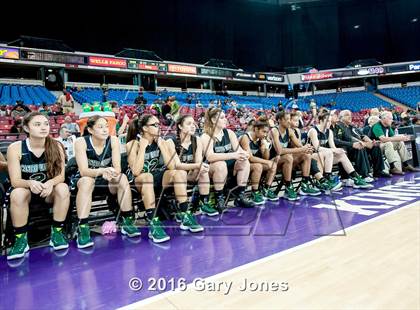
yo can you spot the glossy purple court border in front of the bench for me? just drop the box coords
[0,173,420,309]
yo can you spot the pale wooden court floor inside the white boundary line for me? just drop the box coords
[126,201,420,310]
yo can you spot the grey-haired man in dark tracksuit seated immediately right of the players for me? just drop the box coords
[333,110,389,179]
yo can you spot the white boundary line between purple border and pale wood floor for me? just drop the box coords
[118,200,419,310]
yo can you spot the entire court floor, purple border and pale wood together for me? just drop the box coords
[0,173,420,309]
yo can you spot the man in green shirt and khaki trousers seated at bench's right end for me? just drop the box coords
[370,111,420,174]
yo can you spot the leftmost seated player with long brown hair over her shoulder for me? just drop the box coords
[7,112,70,259]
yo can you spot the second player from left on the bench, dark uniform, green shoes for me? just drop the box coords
[71,116,140,248]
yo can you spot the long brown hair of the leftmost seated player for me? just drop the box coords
[22,112,66,179]
